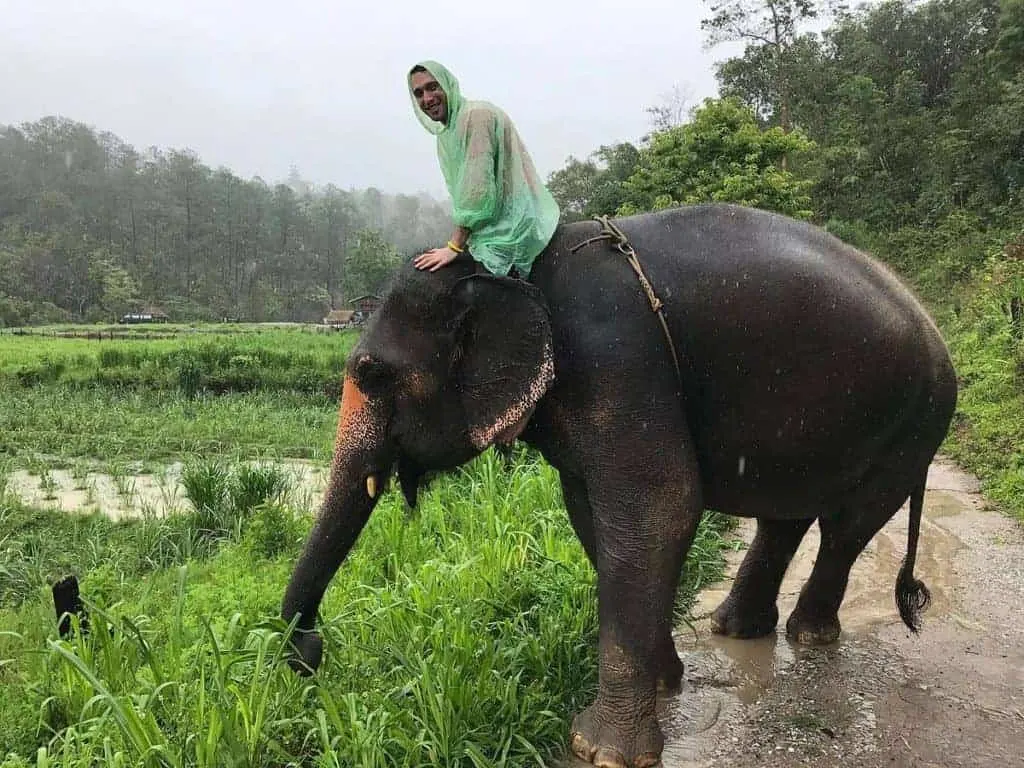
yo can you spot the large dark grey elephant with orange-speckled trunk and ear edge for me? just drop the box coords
[283,205,956,766]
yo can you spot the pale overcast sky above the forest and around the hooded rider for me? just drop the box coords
[0,0,734,195]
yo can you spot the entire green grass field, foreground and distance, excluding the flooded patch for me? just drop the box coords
[0,327,727,768]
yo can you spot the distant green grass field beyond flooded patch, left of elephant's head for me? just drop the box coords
[0,329,357,463]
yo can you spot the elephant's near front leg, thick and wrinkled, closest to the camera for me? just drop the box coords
[571,433,701,768]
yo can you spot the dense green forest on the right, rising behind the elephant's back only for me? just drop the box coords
[551,0,1024,299]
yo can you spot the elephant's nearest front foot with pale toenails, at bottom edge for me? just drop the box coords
[569,702,665,768]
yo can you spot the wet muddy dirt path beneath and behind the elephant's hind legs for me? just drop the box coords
[660,460,1024,768]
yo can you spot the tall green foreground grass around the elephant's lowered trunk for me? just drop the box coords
[0,454,737,768]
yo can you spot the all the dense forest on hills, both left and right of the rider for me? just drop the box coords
[0,0,1024,325]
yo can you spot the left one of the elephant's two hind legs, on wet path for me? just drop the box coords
[712,518,814,638]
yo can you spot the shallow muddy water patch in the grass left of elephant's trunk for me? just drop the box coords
[0,460,328,520]
